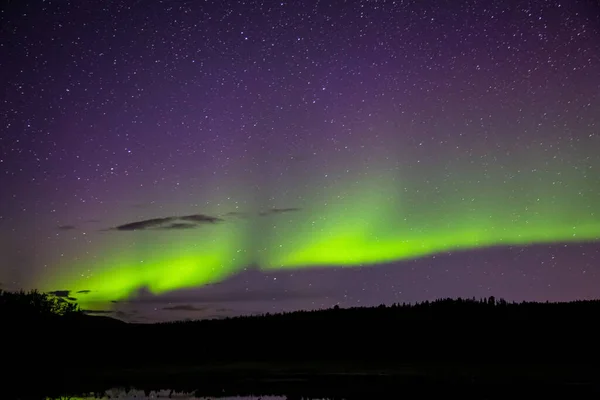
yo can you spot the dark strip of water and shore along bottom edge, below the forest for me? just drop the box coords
[9,364,600,400]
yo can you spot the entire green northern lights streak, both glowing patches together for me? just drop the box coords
[41,162,600,310]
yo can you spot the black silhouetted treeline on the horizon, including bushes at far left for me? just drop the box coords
[0,292,600,368]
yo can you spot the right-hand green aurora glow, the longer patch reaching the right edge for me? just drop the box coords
[261,171,600,269]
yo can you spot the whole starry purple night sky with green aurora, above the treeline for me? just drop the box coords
[0,0,600,322]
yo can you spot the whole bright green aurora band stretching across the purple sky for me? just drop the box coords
[39,167,600,308]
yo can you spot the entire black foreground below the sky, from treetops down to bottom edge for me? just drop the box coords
[1,298,600,399]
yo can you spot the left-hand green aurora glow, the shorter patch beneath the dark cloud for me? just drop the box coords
[43,223,249,309]
